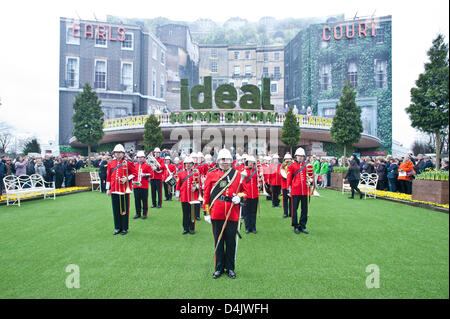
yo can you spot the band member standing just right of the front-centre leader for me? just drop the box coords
[242,155,259,234]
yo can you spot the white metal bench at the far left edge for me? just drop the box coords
[3,174,56,207]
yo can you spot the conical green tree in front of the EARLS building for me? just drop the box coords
[72,83,103,166]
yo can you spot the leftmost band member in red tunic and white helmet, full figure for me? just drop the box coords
[106,144,136,235]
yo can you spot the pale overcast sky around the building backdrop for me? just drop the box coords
[0,0,449,147]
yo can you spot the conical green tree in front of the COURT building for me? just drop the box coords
[330,81,363,156]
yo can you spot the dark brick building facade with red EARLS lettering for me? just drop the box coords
[59,18,167,145]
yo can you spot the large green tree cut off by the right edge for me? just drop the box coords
[406,34,449,169]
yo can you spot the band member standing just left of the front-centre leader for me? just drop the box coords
[175,156,201,235]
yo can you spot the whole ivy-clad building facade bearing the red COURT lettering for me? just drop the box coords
[284,16,392,151]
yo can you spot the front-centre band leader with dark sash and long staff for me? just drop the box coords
[203,149,244,279]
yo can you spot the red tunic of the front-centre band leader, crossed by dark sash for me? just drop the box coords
[203,169,241,221]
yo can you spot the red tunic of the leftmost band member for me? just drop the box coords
[106,159,137,194]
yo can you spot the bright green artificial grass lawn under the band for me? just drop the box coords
[0,190,449,299]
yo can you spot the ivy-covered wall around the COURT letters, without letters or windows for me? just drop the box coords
[285,16,392,152]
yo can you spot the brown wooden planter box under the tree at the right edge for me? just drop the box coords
[412,179,449,204]
